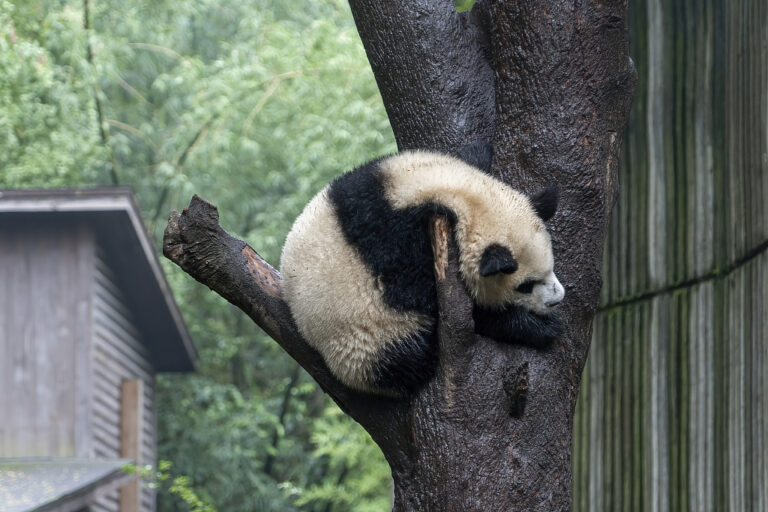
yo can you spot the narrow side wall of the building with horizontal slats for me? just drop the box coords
[92,251,156,512]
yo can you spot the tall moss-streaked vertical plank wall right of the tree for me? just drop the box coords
[573,0,768,512]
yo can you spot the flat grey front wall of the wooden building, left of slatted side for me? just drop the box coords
[0,222,93,457]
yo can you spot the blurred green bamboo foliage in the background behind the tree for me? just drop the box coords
[0,0,395,512]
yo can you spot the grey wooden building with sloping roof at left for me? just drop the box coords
[0,188,196,512]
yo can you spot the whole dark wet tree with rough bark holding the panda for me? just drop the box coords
[164,0,635,511]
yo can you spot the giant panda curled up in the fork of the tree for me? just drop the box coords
[281,151,564,396]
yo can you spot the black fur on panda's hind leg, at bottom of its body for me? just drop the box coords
[373,325,438,395]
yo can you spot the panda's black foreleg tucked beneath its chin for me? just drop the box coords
[473,305,563,348]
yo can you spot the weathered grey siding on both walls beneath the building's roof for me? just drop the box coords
[0,223,156,512]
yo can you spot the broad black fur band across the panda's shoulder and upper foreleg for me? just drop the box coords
[329,160,456,316]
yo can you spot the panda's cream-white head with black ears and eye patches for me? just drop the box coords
[468,188,565,315]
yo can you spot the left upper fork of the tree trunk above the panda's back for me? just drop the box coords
[349,0,494,152]
